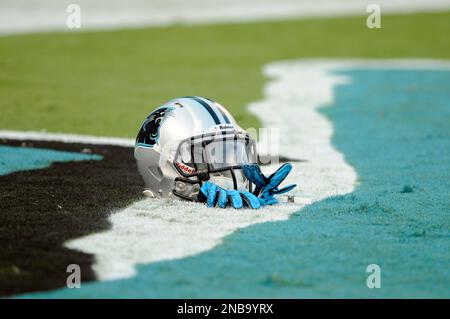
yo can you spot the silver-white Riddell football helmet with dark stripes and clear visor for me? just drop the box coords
[134,96,257,201]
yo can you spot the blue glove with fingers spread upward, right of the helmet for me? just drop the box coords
[242,163,297,205]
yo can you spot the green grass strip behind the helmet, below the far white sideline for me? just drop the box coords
[0,12,450,137]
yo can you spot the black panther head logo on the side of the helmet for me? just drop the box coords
[136,106,174,146]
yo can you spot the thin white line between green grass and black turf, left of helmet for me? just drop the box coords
[0,131,134,147]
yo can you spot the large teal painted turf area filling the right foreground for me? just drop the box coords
[22,70,450,298]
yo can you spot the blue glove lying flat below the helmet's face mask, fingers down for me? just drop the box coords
[198,182,261,209]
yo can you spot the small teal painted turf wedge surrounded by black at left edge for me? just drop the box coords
[0,145,102,175]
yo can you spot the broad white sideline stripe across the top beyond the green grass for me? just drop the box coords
[0,0,450,34]
